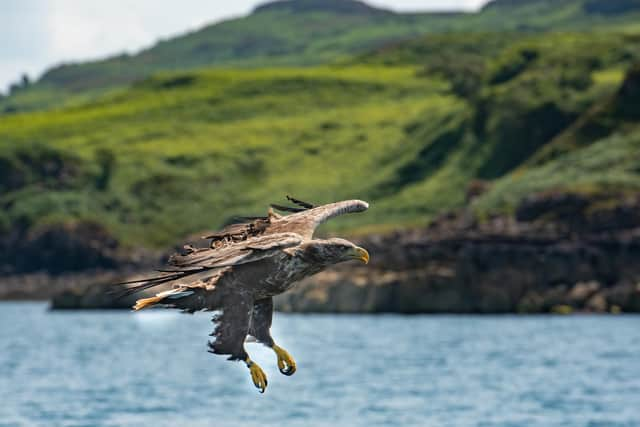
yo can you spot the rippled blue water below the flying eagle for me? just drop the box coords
[0,303,640,427]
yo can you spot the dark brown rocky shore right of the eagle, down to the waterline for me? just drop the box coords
[277,194,640,313]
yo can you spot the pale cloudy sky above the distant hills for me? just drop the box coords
[0,0,487,92]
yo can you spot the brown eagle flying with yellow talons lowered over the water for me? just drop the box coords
[112,196,369,393]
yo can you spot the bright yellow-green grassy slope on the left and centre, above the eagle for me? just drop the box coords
[0,66,464,244]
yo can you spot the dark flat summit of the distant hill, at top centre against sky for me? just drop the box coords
[253,0,393,15]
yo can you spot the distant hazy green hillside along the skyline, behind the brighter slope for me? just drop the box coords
[0,0,640,112]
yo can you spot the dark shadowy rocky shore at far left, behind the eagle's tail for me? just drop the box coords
[0,221,161,308]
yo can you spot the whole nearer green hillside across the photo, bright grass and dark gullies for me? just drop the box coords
[0,24,640,251]
